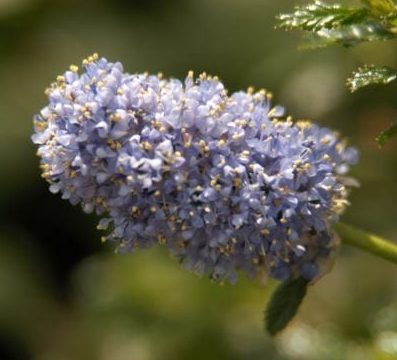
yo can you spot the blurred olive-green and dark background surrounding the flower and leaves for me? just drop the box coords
[0,0,397,360]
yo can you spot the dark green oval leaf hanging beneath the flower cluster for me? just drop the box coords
[265,277,308,335]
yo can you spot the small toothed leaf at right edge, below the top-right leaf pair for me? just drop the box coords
[347,65,397,92]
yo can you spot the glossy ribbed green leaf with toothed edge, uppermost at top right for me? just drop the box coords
[276,1,370,31]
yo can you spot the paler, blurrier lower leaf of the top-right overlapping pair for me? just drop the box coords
[302,21,395,49]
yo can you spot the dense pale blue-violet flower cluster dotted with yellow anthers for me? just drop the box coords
[32,54,357,282]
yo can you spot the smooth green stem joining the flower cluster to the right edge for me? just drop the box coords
[335,223,397,264]
